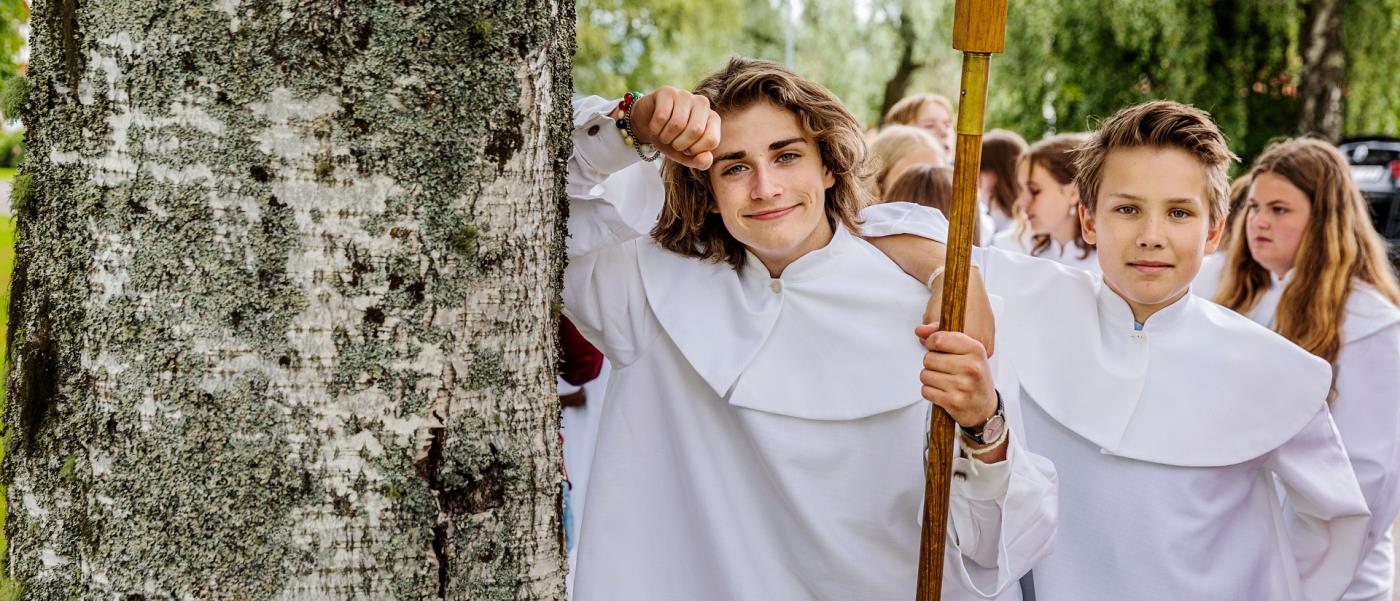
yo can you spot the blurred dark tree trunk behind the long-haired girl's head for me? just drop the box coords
[1298,0,1347,140]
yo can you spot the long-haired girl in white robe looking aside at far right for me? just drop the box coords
[1203,139,1400,601]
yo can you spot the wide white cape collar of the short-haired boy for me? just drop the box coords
[984,251,1331,467]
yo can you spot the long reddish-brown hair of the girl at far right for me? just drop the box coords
[1215,137,1400,363]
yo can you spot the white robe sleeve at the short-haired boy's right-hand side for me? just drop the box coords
[1266,408,1371,601]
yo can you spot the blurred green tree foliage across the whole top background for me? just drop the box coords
[574,0,1400,160]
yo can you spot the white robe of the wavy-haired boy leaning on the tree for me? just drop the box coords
[564,98,1057,601]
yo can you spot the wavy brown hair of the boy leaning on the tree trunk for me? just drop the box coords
[651,56,874,269]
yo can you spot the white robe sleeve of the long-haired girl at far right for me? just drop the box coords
[1331,324,1400,577]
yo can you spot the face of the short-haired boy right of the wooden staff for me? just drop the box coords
[1079,147,1224,322]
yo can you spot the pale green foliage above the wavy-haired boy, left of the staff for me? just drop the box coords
[574,0,958,125]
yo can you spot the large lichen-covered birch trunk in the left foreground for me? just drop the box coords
[4,0,574,601]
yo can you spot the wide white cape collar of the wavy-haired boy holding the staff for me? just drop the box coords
[637,227,928,420]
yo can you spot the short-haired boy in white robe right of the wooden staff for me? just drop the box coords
[865,101,1366,601]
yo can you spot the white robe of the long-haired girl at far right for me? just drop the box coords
[1226,272,1400,601]
